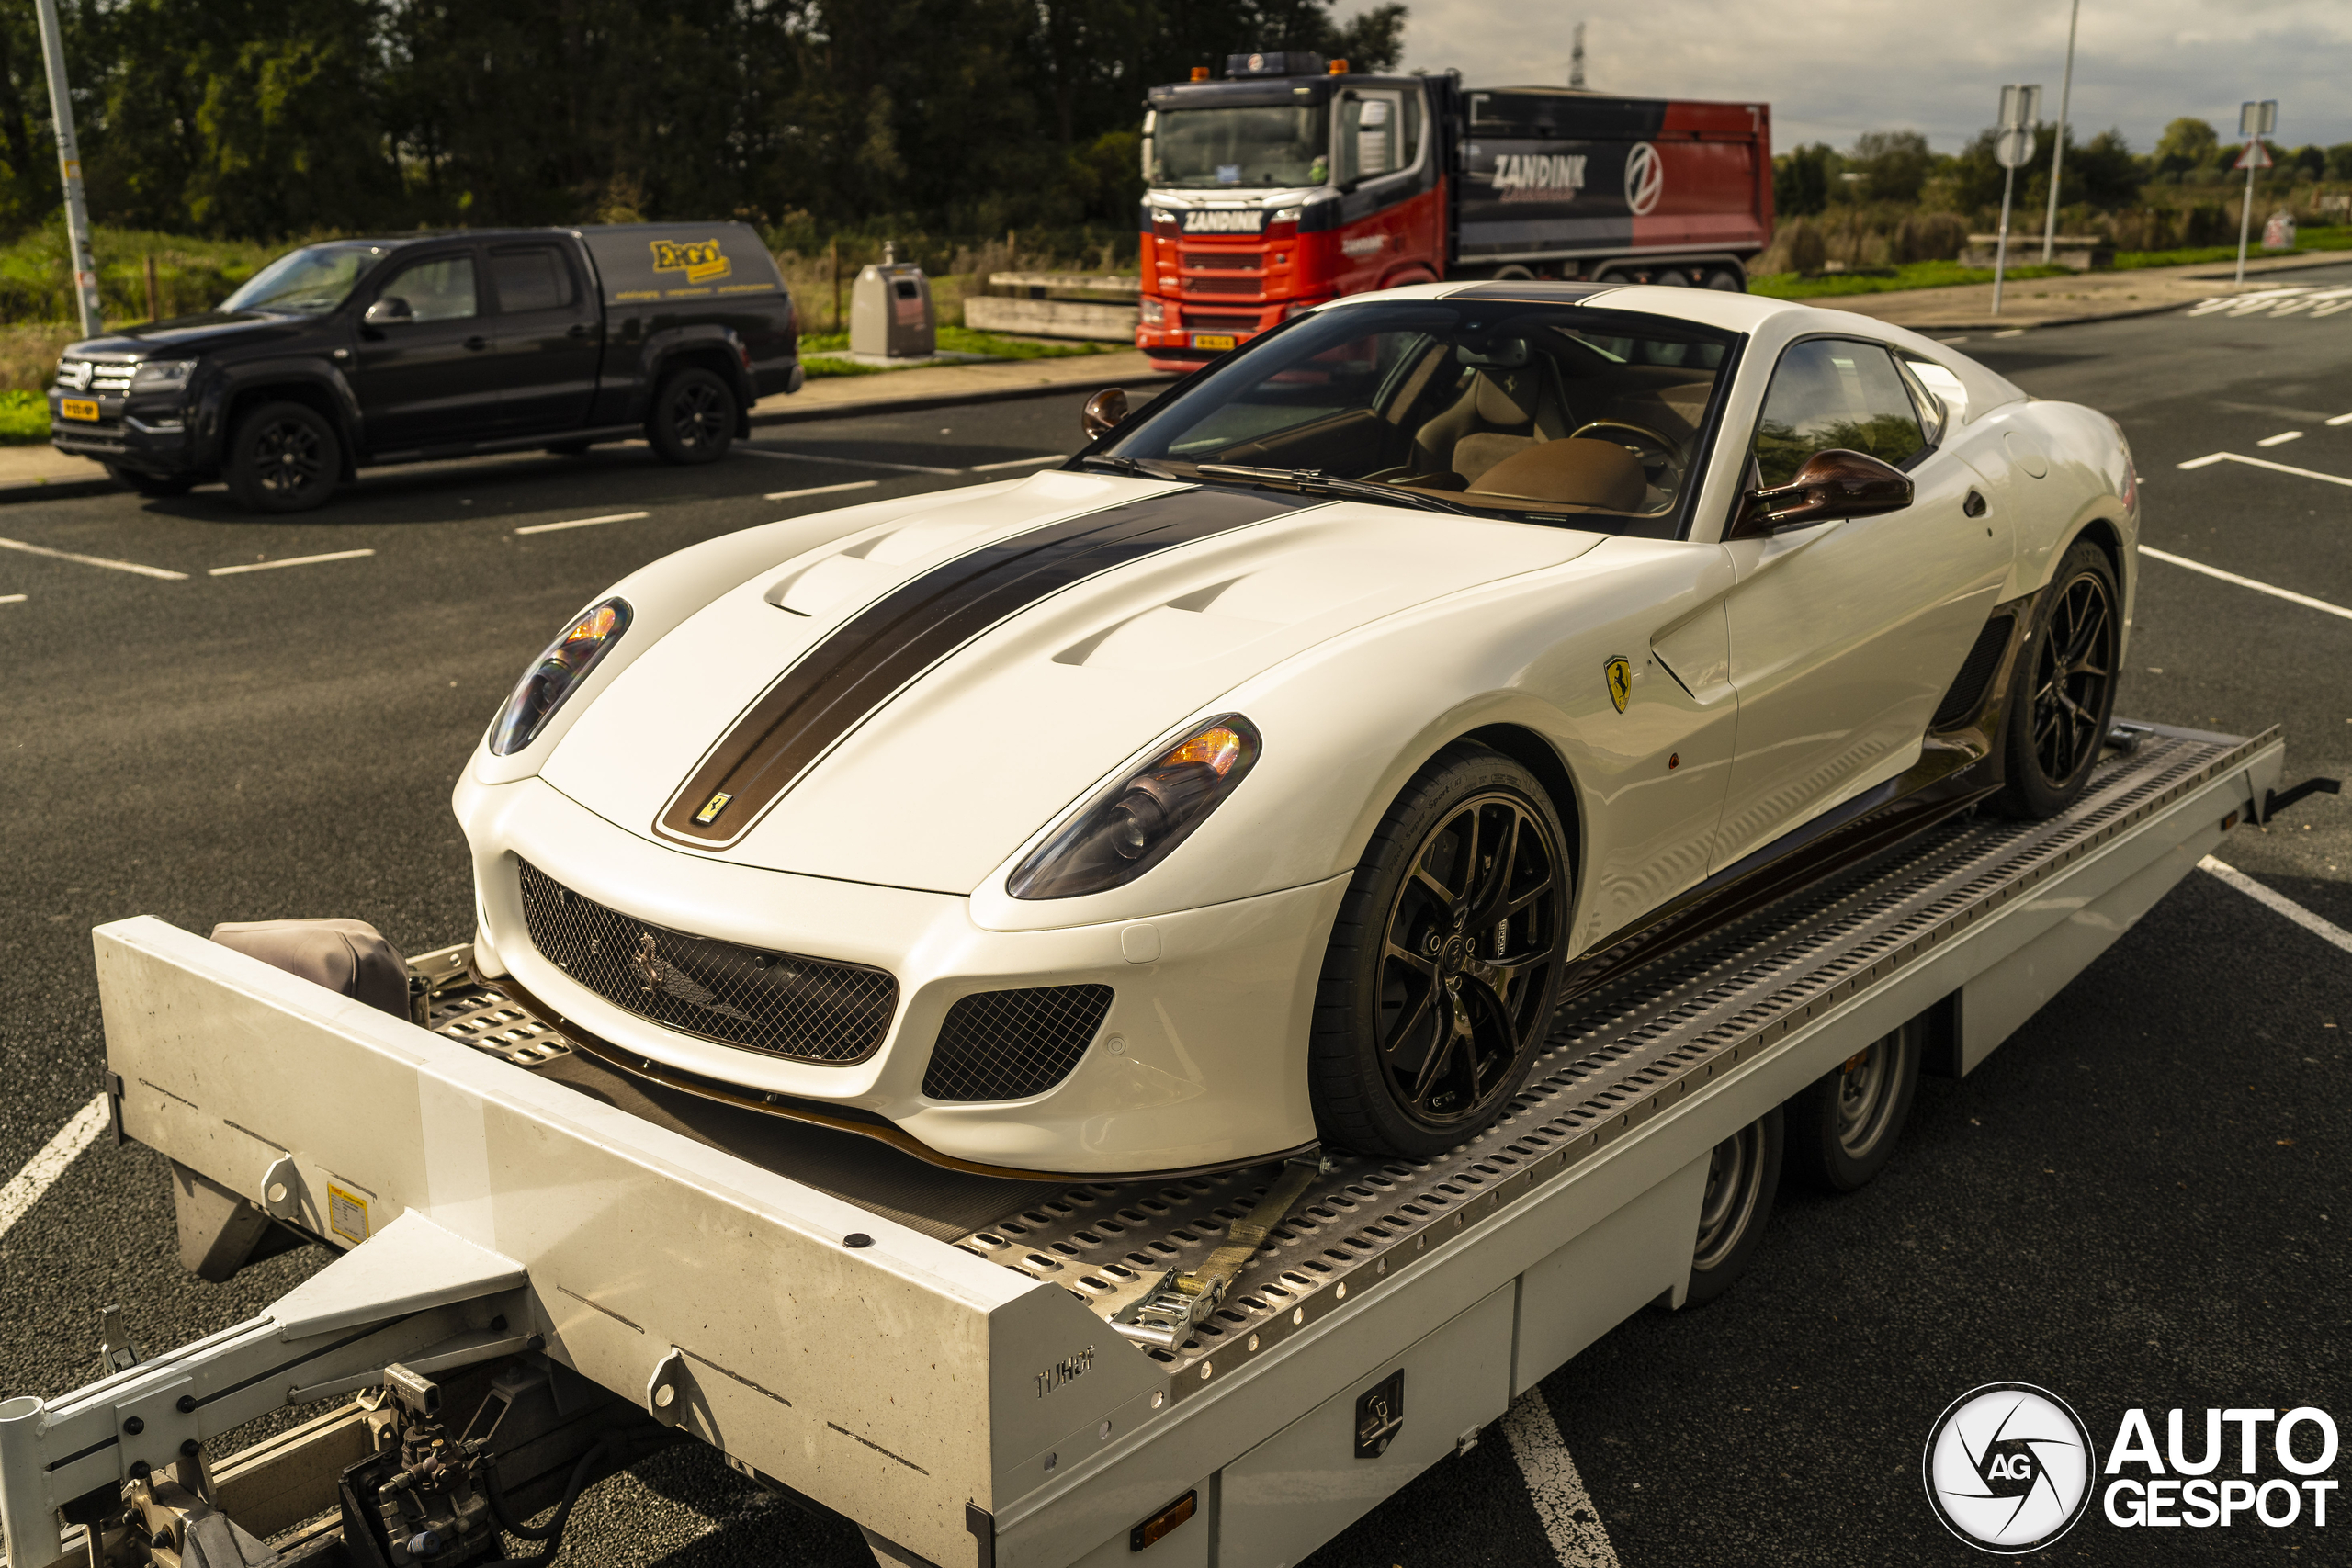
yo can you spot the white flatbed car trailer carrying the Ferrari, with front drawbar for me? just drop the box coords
[0,724,2301,1568]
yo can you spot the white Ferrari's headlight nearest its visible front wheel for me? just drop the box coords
[1004,712,1259,898]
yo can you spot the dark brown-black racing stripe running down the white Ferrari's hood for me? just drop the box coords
[659,489,1322,849]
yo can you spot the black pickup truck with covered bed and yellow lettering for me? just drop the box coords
[50,223,802,513]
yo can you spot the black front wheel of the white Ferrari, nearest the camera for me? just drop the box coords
[1307,745,1569,1159]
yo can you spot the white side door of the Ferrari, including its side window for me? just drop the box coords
[1714,339,2011,865]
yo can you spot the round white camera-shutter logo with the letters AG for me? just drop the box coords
[1922,1382,2098,1556]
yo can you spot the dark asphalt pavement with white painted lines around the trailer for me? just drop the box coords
[0,288,2352,1568]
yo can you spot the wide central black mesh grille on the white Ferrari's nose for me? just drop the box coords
[517,861,899,1067]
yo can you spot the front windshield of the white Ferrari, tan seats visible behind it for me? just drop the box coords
[1087,299,1736,538]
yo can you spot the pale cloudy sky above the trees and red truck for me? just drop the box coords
[1336,0,2352,152]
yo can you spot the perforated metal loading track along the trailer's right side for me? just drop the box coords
[957,727,2277,1399]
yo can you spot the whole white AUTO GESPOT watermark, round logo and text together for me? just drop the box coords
[1922,1382,2338,1556]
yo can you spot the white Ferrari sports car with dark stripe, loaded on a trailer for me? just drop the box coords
[457,282,2138,1176]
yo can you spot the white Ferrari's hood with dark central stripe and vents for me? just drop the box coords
[543,472,1600,894]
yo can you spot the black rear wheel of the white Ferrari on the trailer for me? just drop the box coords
[1999,538,2121,818]
